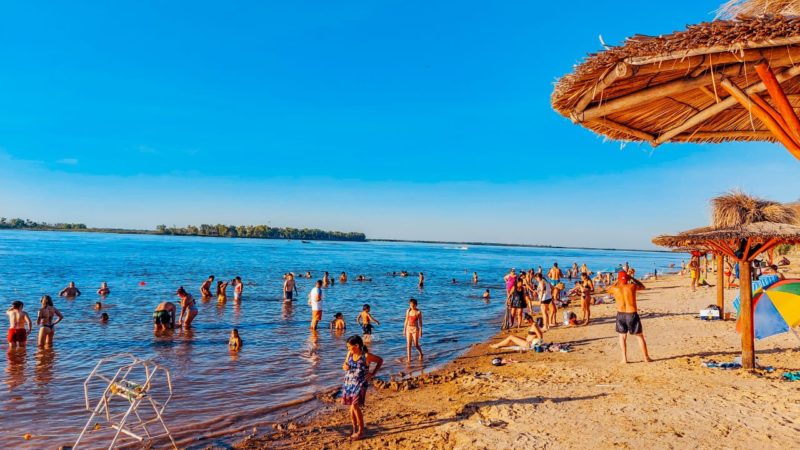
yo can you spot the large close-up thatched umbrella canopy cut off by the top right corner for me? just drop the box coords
[551,0,800,159]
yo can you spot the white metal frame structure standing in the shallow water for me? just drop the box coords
[73,353,178,450]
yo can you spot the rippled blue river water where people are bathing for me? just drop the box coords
[0,231,680,448]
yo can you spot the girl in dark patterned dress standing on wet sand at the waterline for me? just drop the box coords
[342,336,383,441]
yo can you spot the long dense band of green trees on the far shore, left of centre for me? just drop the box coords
[156,224,367,241]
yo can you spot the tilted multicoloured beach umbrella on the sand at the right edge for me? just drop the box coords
[736,280,800,339]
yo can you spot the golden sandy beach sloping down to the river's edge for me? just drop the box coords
[230,264,800,450]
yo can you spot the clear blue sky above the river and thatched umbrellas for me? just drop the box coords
[0,0,800,248]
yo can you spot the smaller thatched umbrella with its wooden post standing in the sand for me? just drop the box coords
[653,192,800,369]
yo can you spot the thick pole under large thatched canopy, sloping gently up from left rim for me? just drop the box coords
[570,73,722,123]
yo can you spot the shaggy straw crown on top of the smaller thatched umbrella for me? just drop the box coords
[711,191,797,228]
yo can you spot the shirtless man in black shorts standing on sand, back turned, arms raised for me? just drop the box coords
[608,271,651,364]
